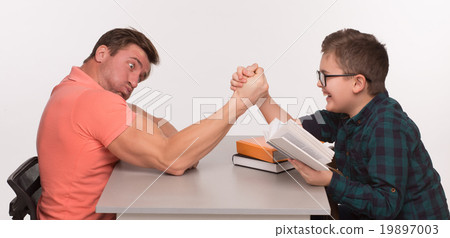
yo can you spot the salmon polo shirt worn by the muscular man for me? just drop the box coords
[37,67,135,220]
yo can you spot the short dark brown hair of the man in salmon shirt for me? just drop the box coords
[84,28,159,67]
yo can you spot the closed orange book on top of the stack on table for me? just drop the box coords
[236,136,288,163]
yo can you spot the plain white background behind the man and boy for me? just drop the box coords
[0,0,450,219]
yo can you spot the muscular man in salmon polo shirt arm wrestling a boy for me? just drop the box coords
[37,29,268,219]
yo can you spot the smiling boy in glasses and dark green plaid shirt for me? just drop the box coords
[231,29,449,219]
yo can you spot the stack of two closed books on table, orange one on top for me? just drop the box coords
[232,137,294,173]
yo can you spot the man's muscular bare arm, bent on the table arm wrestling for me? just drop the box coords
[108,70,268,175]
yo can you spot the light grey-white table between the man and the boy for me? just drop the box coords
[96,136,330,219]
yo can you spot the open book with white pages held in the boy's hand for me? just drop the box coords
[265,119,334,171]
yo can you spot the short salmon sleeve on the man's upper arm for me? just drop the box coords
[71,90,135,147]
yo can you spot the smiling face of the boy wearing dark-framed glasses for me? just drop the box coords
[317,53,355,114]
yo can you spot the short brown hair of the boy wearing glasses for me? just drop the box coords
[322,29,389,95]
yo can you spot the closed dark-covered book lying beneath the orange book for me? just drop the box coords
[232,154,294,174]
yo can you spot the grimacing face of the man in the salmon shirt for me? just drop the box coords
[99,44,150,100]
